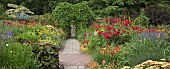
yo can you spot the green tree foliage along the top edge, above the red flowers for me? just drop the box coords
[89,0,162,17]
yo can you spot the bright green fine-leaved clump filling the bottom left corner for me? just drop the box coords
[0,42,38,69]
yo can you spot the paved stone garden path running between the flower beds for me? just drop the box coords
[59,39,90,69]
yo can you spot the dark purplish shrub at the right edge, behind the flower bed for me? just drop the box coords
[145,4,170,25]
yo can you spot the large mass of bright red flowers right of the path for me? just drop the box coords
[91,17,147,45]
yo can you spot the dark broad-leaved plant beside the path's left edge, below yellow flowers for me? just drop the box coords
[33,44,59,69]
